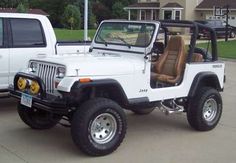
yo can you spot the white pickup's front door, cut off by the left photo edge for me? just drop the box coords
[0,18,9,91]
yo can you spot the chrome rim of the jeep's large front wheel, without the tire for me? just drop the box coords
[90,113,117,144]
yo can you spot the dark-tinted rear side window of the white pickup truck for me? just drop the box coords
[10,19,46,47]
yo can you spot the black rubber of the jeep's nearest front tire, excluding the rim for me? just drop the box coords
[71,98,127,156]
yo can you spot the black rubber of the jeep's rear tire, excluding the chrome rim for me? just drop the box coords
[187,87,222,131]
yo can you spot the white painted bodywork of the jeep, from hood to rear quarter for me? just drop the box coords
[55,52,225,101]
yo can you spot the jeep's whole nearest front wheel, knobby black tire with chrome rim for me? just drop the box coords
[71,98,127,156]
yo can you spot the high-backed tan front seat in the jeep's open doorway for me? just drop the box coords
[152,36,186,85]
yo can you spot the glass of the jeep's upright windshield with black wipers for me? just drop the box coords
[95,22,155,47]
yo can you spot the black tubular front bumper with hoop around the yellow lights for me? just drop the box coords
[9,73,69,115]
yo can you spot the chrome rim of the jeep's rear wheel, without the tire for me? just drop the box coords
[203,98,217,122]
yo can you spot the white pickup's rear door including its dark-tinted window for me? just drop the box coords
[9,18,49,84]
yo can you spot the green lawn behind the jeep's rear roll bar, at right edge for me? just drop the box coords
[198,40,236,59]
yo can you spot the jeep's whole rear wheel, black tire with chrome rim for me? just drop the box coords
[187,87,222,131]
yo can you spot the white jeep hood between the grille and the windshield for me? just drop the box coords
[33,54,144,76]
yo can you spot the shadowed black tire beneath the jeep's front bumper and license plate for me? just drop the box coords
[17,104,61,129]
